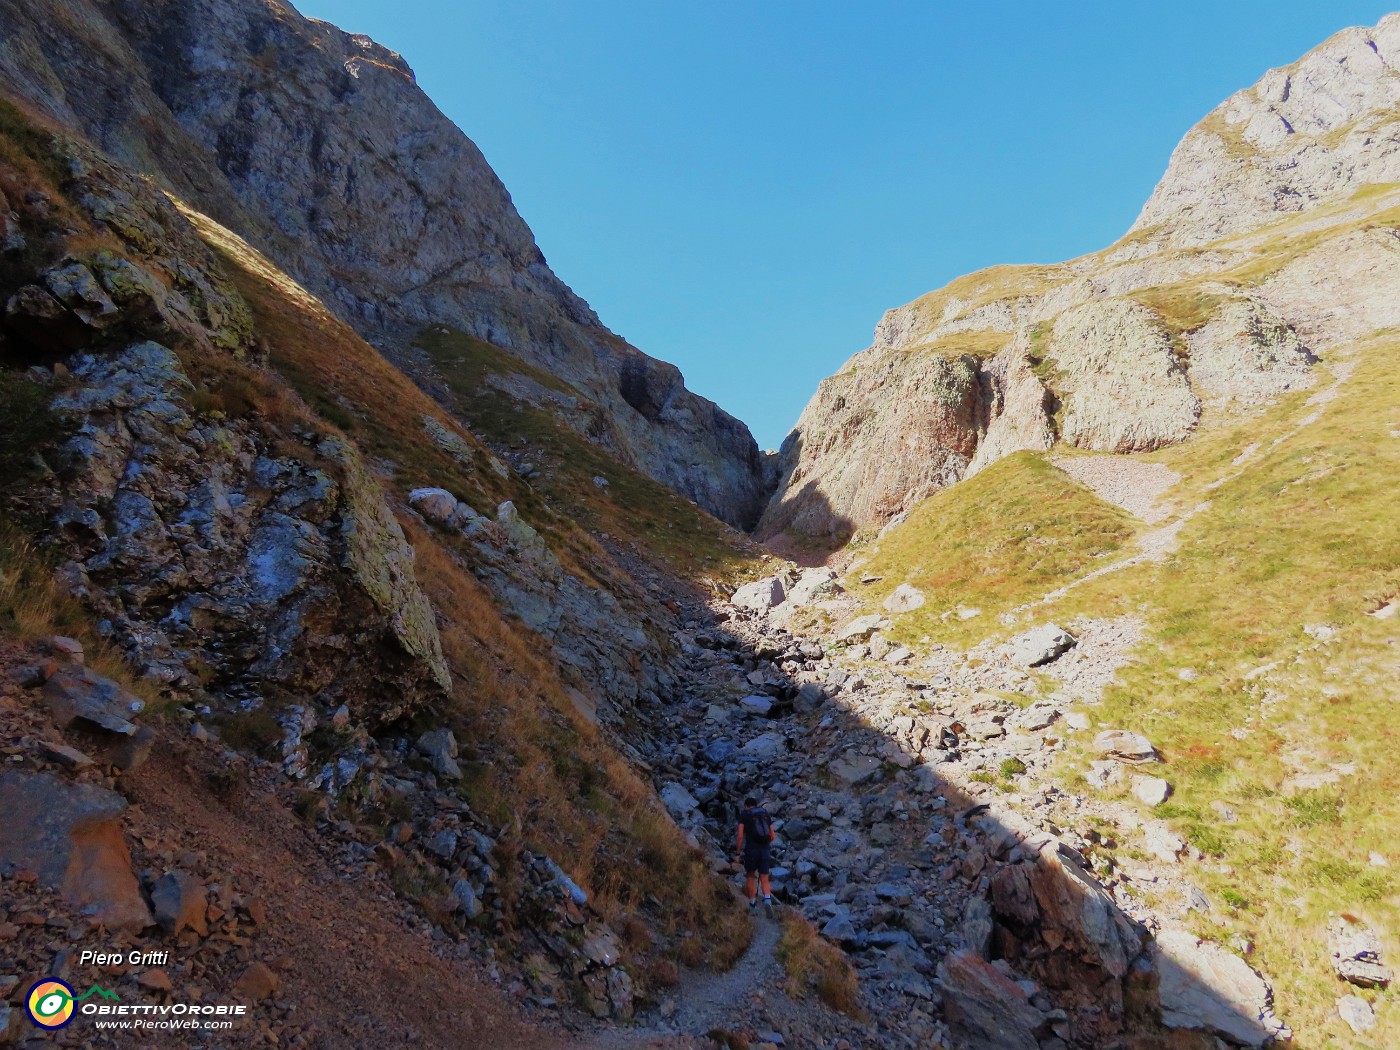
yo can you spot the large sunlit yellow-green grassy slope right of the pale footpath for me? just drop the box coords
[1046,336,1400,1047]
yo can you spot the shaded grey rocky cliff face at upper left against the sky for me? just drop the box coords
[0,0,770,525]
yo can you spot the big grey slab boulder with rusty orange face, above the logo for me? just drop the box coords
[0,770,151,932]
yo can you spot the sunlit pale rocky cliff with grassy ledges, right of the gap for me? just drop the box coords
[759,15,1400,543]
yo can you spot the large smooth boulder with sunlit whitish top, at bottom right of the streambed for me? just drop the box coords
[1152,930,1288,1047]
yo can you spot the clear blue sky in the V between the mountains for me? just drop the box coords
[297,0,1394,447]
